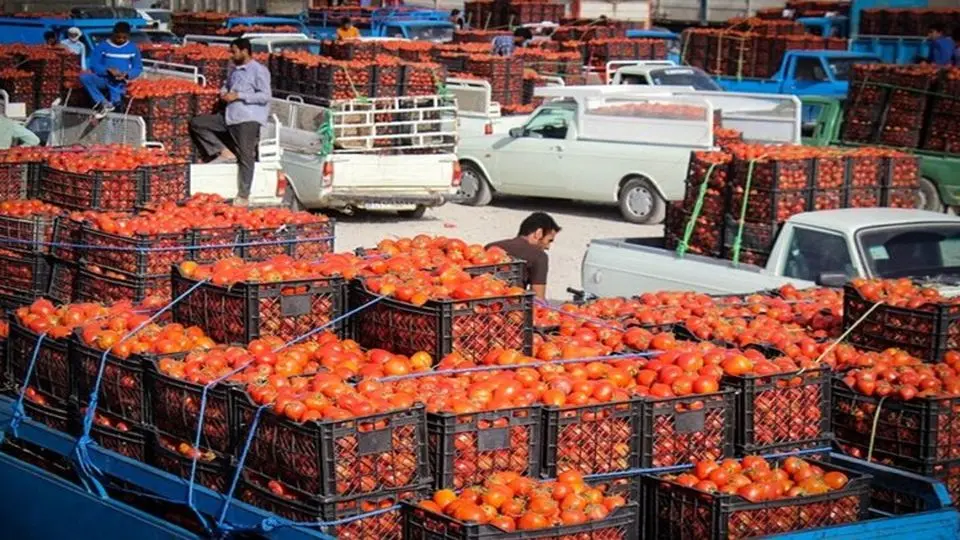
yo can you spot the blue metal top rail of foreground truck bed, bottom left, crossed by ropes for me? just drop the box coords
[0,396,332,540]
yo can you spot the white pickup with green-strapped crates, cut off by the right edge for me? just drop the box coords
[581,208,960,296]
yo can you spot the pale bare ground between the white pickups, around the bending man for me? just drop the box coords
[335,198,662,300]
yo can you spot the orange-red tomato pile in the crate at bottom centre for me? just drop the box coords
[417,471,628,532]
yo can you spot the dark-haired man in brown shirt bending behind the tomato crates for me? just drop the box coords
[487,212,560,300]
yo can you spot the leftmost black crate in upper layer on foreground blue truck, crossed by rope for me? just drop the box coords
[7,316,73,407]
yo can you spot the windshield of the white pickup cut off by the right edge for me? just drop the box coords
[857,223,960,278]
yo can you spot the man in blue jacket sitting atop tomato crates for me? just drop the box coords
[80,21,143,118]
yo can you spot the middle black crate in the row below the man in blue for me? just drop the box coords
[39,165,144,212]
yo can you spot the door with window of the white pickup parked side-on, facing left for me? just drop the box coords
[496,104,576,197]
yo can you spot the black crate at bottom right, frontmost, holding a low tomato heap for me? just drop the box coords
[642,460,870,540]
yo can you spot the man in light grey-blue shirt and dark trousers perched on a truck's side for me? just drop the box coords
[190,38,271,206]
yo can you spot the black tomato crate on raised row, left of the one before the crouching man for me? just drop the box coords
[172,266,346,343]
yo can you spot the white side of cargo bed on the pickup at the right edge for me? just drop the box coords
[581,238,813,296]
